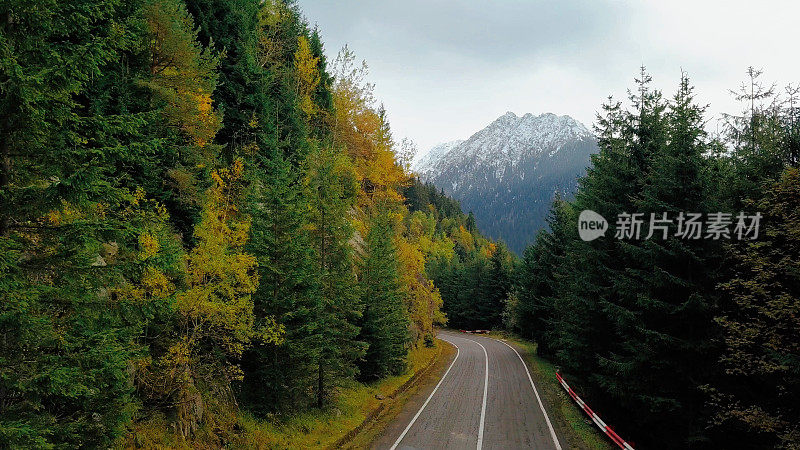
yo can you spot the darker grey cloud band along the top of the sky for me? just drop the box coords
[301,0,627,66]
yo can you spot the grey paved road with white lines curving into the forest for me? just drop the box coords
[374,332,563,450]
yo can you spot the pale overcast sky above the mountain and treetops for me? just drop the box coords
[299,0,800,152]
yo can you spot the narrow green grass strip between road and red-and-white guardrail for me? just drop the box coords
[489,332,615,450]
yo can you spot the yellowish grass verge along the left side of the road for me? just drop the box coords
[125,339,455,449]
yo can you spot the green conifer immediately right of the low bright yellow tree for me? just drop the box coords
[243,148,324,413]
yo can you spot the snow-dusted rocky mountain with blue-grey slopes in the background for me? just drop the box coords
[412,112,597,253]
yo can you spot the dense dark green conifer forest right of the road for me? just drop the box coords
[506,68,800,448]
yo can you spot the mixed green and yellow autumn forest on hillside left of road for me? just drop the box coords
[0,0,452,448]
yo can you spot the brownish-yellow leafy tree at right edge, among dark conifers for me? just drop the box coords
[711,168,800,448]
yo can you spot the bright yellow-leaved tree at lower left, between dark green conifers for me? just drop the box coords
[165,160,282,435]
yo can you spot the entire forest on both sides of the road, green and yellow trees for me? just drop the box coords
[0,0,800,449]
